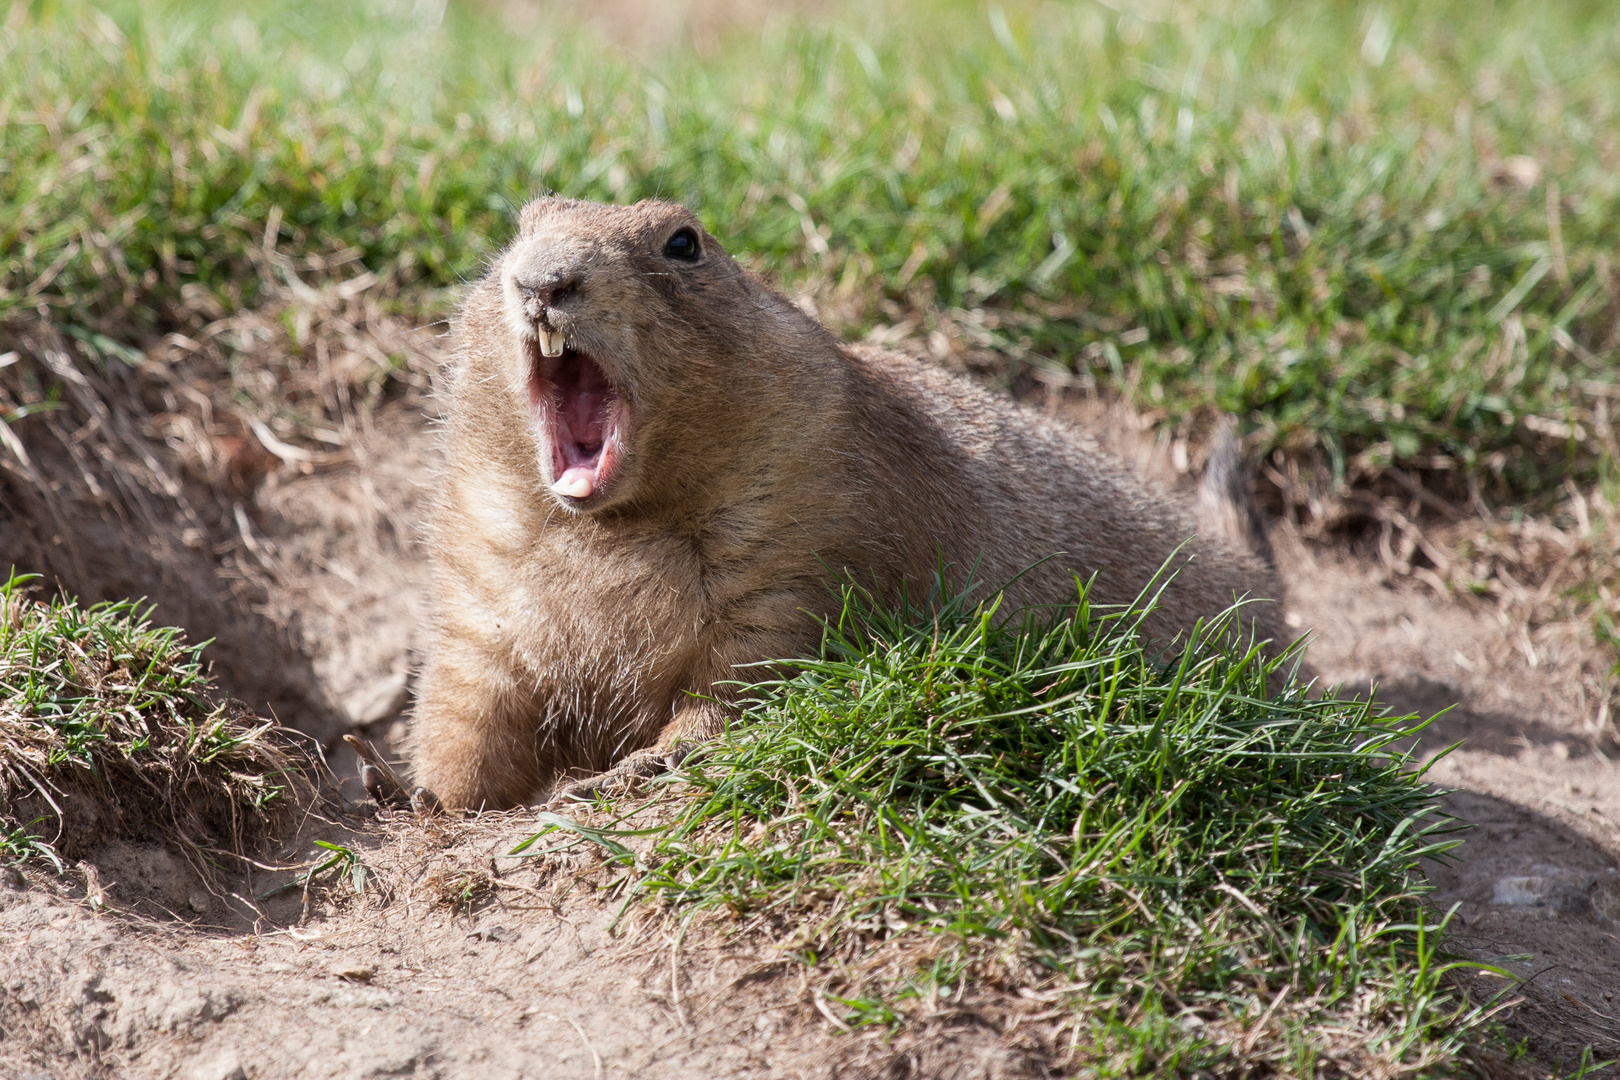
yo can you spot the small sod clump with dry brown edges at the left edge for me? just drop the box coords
[0,572,308,870]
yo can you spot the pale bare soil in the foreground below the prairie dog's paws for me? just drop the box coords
[0,814,1029,1080]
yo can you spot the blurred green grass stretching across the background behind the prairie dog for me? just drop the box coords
[0,0,1620,492]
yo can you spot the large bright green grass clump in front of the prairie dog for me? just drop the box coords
[536,573,1487,1075]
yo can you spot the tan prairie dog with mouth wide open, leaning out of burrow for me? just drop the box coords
[413,198,1283,808]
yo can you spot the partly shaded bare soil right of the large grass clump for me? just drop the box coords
[1280,542,1620,1062]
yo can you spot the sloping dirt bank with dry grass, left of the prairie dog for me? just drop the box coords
[0,272,439,746]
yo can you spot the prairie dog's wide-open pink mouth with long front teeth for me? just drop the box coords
[528,334,629,500]
